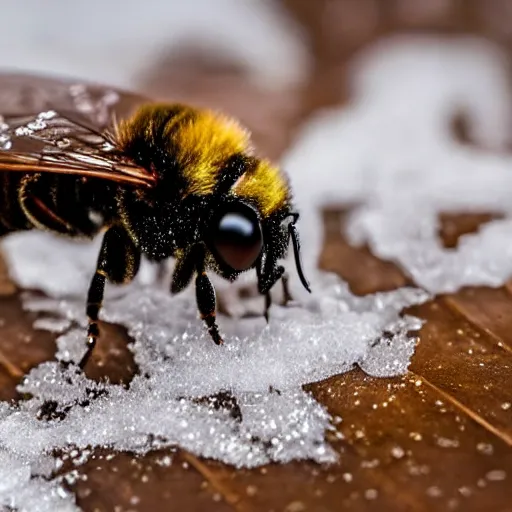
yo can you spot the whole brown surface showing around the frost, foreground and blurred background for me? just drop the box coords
[0,0,512,512]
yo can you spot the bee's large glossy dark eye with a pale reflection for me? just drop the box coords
[213,212,263,271]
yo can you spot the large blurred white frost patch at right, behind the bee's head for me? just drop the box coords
[285,37,512,293]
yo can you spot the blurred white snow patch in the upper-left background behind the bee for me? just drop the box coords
[0,0,310,89]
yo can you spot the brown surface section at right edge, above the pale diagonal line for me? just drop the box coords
[410,295,512,446]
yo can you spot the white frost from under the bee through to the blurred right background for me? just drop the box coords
[0,35,512,510]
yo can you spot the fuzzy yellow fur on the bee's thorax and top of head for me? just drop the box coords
[115,104,290,218]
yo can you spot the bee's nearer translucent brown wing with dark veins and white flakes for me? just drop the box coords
[0,110,155,187]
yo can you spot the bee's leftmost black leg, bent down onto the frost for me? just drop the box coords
[78,226,140,370]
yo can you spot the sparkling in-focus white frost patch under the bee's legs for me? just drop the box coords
[0,232,427,508]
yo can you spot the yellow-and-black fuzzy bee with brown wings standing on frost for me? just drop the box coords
[0,74,310,369]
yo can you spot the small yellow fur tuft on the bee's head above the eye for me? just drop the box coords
[233,160,289,217]
